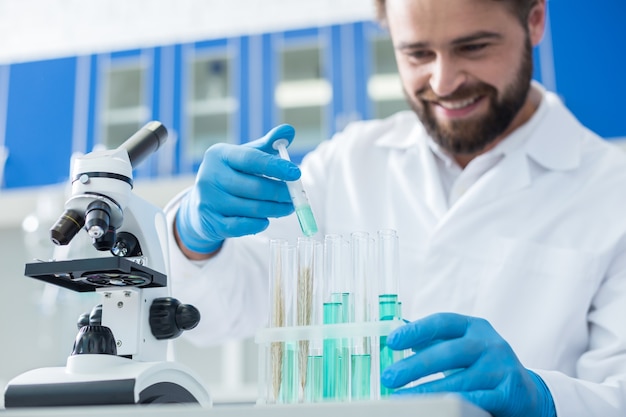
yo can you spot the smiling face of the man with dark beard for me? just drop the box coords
[387,0,532,155]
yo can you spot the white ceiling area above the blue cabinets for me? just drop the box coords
[0,0,374,64]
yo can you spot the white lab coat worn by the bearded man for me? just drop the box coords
[169,87,626,417]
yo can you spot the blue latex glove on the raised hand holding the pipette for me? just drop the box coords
[176,125,300,254]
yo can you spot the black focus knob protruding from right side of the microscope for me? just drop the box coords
[150,297,200,340]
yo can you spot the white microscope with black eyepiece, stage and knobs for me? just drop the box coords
[5,121,211,408]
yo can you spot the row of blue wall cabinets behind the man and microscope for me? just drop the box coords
[0,13,626,188]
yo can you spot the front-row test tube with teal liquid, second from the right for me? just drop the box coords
[349,232,374,400]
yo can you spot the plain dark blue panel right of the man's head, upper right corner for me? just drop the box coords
[548,0,626,138]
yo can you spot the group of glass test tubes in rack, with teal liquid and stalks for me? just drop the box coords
[256,230,405,404]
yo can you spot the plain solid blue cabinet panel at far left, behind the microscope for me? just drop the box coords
[4,58,76,188]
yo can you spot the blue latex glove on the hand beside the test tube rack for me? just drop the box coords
[381,313,556,417]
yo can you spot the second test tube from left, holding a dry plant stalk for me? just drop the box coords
[297,238,324,402]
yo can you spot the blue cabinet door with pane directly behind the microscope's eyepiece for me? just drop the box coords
[88,46,180,178]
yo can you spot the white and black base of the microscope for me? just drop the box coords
[4,355,211,408]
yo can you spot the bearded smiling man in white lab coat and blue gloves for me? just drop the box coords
[169,0,626,417]
